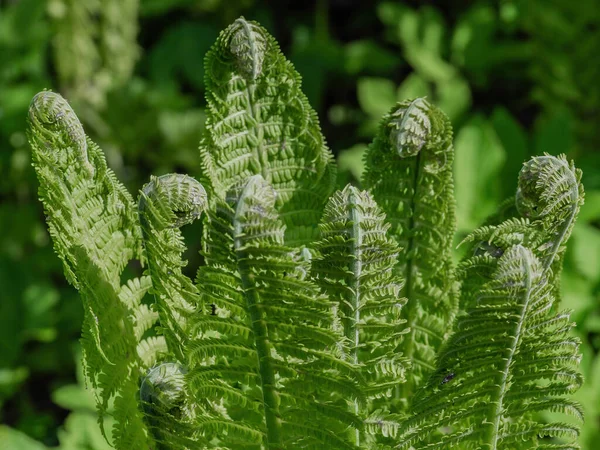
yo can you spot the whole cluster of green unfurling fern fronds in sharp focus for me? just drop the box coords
[29,18,583,450]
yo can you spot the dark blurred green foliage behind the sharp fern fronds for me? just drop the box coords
[0,0,600,450]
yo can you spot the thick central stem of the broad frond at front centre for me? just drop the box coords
[233,177,284,450]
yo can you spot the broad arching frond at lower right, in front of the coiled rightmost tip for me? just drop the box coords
[398,245,583,449]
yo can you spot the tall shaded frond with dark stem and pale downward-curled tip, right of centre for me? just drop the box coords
[364,98,456,402]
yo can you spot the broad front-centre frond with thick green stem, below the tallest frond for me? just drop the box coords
[187,175,363,449]
